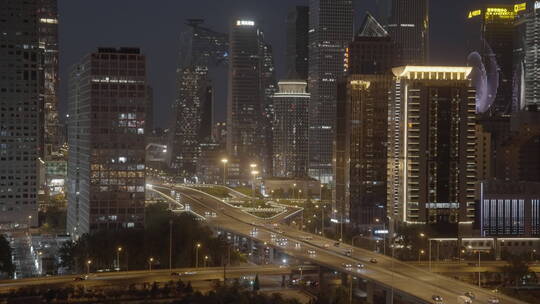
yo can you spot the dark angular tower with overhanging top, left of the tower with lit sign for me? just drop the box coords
[169,19,229,178]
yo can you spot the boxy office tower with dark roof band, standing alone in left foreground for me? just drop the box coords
[67,48,148,239]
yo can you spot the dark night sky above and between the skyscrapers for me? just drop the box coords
[58,0,514,127]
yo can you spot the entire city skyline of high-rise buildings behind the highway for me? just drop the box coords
[0,0,540,238]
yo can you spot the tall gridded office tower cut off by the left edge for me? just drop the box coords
[0,0,44,225]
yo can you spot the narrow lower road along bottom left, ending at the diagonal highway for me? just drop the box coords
[0,265,292,293]
